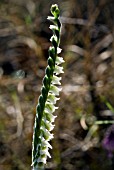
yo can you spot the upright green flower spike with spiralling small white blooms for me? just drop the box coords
[32,4,64,170]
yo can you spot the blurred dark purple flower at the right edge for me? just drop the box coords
[103,125,114,157]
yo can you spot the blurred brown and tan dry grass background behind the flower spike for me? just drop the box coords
[0,0,114,170]
